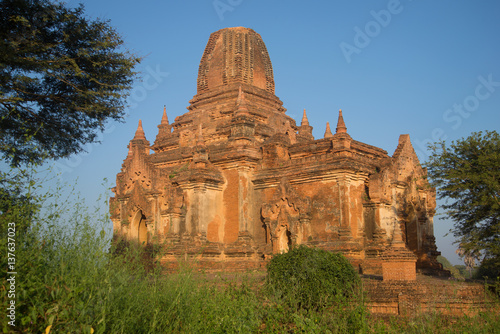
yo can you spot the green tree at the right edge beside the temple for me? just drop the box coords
[426,131,500,277]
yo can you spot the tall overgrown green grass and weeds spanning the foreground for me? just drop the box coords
[0,168,500,333]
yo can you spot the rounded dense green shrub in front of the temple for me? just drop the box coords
[266,246,360,310]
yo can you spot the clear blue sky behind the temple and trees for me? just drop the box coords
[37,0,500,263]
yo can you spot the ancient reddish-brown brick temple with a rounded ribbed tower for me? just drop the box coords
[111,27,440,273]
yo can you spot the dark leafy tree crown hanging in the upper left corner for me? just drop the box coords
[0,0,140,165]
